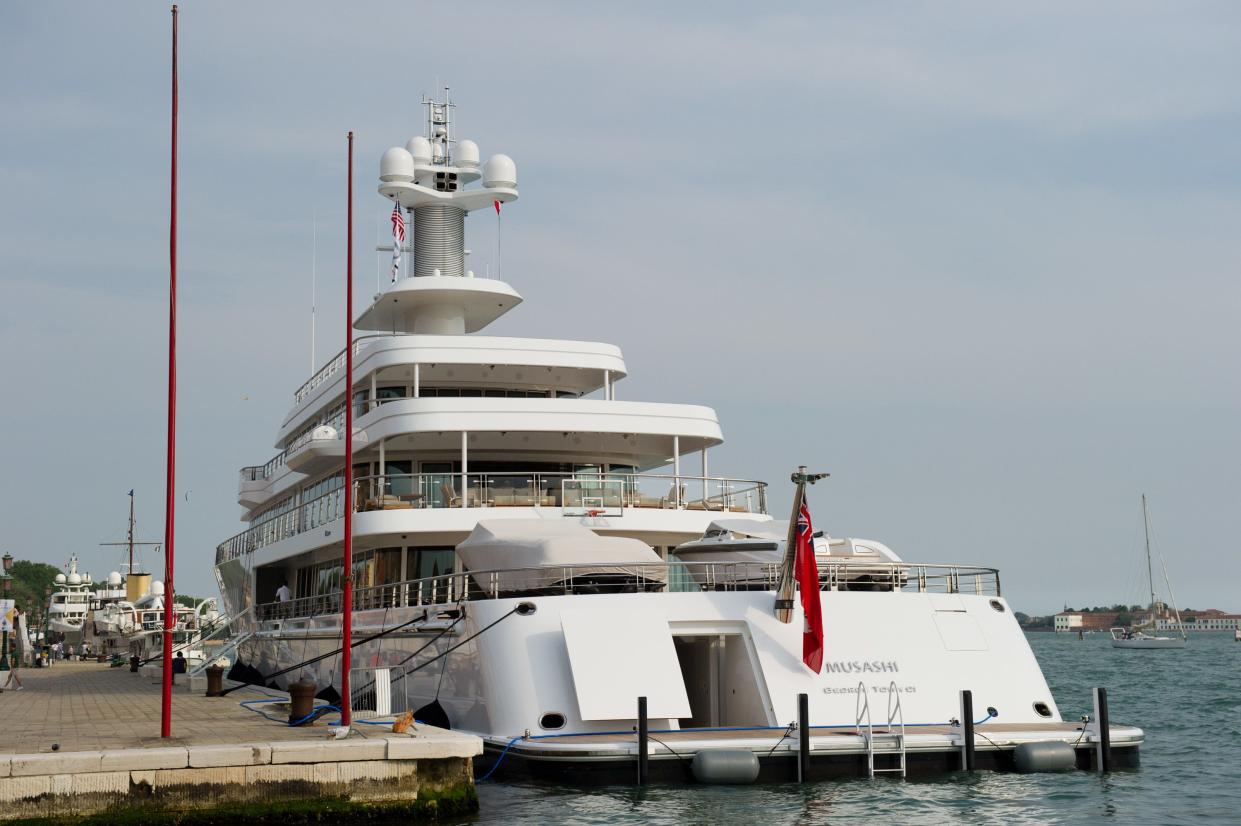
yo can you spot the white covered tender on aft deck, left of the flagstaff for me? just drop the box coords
[457,520,668,592]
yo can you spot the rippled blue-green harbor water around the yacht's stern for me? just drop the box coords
[460,630,1241,826]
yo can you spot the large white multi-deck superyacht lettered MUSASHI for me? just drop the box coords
[216,94,1142,780]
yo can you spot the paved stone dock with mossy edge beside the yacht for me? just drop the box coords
[0,662,483,826]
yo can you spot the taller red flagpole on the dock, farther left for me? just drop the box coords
[161,6,176,737]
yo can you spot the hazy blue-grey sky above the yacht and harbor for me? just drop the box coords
[0,0,1241,613]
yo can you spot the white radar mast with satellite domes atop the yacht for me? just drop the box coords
[367,88,521,335]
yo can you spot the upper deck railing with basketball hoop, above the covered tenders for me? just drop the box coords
[216,473,767,564]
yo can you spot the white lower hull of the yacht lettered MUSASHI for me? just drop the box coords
[223,590,1142,779]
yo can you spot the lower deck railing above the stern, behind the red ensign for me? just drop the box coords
[257,557,1000,620]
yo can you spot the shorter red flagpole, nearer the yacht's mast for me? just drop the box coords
[340,127,354,728]
